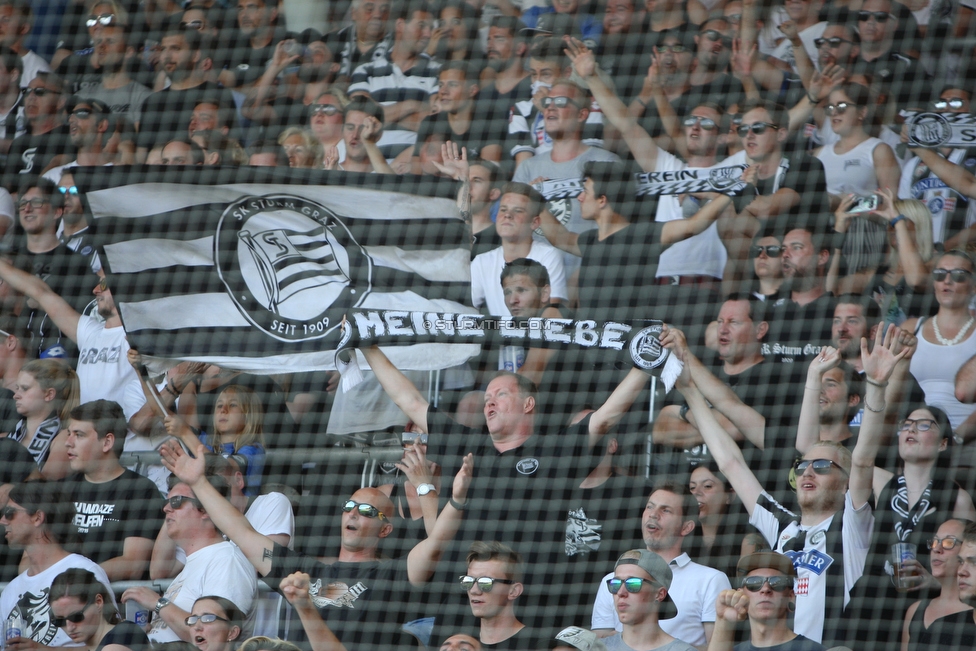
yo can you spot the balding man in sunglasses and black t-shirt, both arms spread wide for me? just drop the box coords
[162,442,474,649]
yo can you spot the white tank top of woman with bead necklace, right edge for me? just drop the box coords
[909,319,976,429]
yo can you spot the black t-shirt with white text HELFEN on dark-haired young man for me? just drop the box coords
[64,470,163,570]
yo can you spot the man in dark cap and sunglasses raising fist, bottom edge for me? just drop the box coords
[708,552,824,651]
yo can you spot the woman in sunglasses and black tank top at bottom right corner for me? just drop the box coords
[901,518,976,651]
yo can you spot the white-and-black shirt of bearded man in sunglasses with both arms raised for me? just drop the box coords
[749,492,874,643]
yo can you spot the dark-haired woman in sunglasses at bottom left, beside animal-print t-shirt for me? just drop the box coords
[47,568,149,651]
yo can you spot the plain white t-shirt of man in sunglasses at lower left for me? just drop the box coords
[149,541,258,644]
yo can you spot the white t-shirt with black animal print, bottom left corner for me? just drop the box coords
[0,554,115,646]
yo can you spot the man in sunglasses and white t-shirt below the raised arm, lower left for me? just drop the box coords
[121,474,258,644]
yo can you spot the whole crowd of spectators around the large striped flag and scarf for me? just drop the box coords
[0,0,976,651]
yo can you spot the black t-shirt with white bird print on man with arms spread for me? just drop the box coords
[264,543,419,650]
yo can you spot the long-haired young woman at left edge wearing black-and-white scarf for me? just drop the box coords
[8,359,80,479]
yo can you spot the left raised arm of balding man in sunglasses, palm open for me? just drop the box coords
[159,441,274,576]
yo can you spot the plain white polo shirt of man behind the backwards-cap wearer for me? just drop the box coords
[590,554,732,647]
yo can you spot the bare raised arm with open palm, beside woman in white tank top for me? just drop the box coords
[848,325,908,509]
